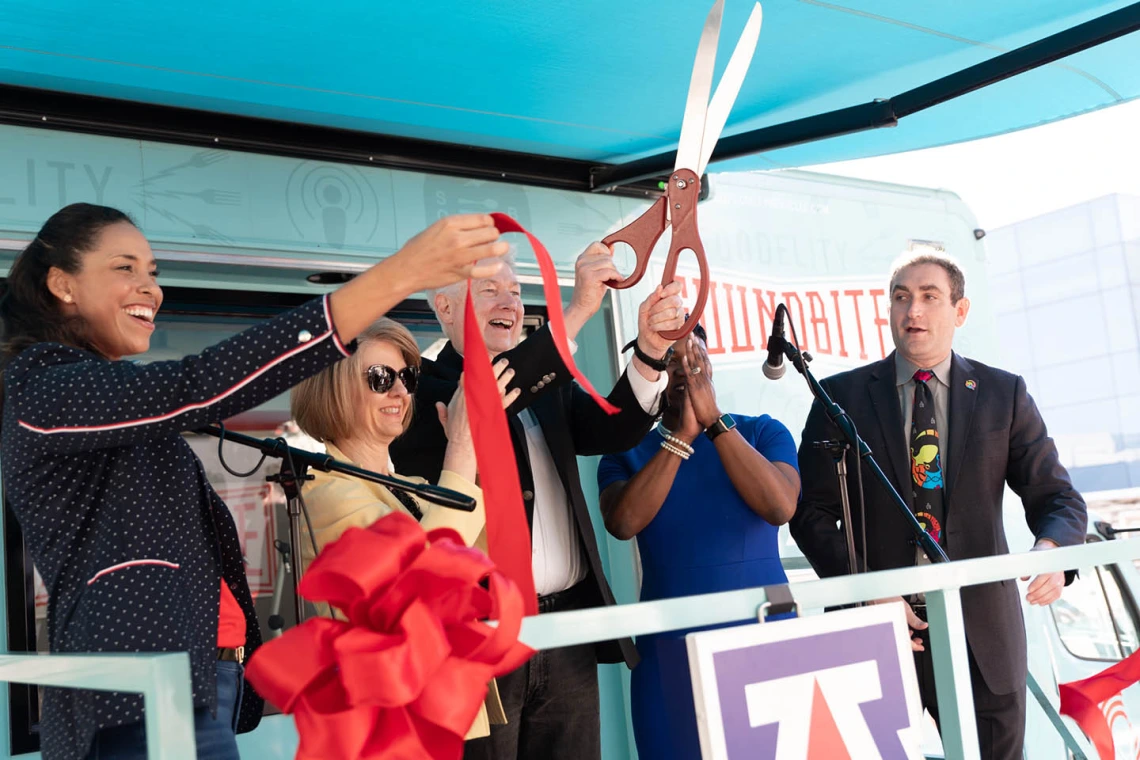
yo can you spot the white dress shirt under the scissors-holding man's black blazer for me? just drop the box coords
[531,360,669,596]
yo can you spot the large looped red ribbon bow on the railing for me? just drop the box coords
[246,513,534,760]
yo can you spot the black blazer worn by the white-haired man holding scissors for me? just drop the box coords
[389,327,653,668]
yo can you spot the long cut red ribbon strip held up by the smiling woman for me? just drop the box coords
[463,214,620,615]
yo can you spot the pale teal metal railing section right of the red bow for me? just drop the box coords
[520,539,1140,760]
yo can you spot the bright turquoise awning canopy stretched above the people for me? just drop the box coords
[0,0,1140,171]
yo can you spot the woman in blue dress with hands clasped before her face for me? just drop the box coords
[597,327,799,760]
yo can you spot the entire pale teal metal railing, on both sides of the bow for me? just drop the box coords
[0,539,1140,760]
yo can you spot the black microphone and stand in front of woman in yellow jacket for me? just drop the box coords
[192,425,475,624]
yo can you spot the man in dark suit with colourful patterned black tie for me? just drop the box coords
[791,255,1088,760]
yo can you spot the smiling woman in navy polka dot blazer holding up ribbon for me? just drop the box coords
[0,204,506,760]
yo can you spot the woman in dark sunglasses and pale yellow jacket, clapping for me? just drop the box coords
[290,318,522,738]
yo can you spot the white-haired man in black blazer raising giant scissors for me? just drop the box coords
[391,243,684,760]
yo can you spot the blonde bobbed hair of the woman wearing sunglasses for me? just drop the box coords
[290,317,420,443]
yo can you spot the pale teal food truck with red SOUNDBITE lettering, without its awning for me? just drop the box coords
[0,126,1140,758]
